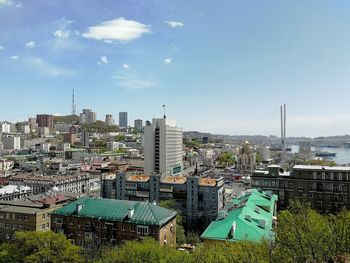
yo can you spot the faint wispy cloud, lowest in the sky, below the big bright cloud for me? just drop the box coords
[112,73,157,89]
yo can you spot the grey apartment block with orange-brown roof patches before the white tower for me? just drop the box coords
[101,173,224,231]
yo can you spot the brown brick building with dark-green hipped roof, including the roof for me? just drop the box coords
[51,197,176,248]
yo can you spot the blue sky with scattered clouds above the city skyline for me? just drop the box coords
[0,0,350,137]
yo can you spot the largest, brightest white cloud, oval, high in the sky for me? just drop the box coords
[83,17,151,43]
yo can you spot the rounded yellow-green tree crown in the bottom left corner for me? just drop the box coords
[0,231,83,263]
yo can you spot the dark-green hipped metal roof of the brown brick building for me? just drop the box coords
[52,197,176,226]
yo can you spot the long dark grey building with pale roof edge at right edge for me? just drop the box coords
[252,165,350,213]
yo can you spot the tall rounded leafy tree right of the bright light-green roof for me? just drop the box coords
[273,201,334,262]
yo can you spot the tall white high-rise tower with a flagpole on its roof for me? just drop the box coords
[144,118,183,175]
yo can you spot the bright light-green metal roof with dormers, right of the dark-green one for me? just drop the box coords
[201,189,278,242]
